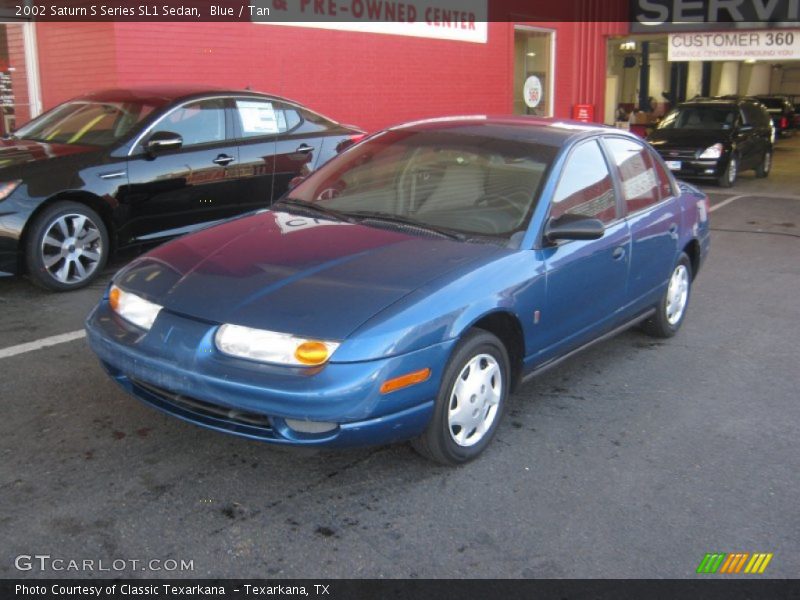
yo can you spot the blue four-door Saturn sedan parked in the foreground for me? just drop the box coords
[86,117,709,464]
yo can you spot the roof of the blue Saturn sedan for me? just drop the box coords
[390,115,624,147]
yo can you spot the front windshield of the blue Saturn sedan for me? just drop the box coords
[285,126,557,237]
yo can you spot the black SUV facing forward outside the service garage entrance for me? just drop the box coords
[647,98,775,187]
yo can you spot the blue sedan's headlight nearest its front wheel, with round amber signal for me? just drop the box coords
[214,324,339,367]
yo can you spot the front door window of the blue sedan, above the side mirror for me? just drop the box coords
[550,141,617,223]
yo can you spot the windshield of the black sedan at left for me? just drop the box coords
[14,100,156,146]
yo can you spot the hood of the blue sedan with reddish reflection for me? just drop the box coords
[115,211,502,340]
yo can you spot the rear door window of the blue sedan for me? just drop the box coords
[605,138,661,213]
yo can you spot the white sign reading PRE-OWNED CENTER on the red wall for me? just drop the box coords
[253,0,488,44]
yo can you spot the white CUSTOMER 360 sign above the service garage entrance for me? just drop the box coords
[667,29,800,61]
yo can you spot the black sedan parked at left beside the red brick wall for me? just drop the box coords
[0,87,363,290]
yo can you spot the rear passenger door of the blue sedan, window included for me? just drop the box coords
[604,136,680,310]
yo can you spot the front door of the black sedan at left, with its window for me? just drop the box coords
[118,98,240,240]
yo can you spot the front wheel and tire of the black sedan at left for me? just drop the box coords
[25,202,109,292]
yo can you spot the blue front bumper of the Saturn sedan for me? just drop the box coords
[86,299,455,447]
